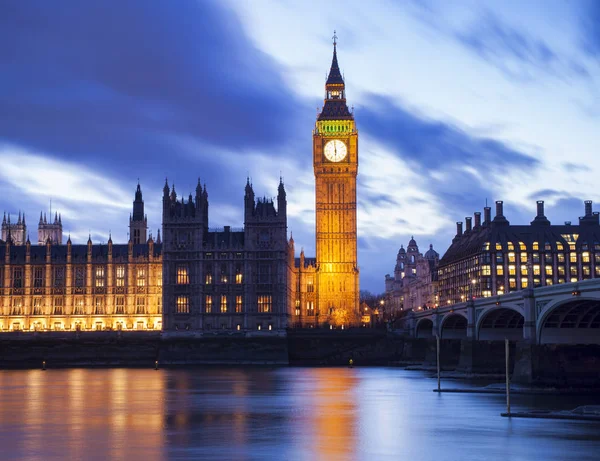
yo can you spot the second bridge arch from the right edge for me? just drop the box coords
[476,305,525,341]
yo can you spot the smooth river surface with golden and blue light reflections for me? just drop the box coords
[0,368,600,461]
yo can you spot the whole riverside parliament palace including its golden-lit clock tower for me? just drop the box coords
[0,40,359,334]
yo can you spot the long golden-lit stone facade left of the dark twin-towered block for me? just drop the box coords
[0,186,162,331]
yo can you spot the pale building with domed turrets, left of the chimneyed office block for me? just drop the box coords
[384,237,440,317]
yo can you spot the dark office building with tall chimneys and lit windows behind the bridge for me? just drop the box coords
[438,201,600,304]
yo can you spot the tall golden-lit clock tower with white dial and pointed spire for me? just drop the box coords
[313,34,359,326]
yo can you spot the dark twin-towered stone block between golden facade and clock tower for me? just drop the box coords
[163,176,291,331]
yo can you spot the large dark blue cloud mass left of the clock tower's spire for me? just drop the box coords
[0,0,310,176]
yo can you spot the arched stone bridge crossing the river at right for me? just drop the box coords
[404,279,600,344]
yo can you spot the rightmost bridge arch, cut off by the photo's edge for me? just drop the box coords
[537,296,600,344]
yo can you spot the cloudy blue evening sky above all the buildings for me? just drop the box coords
[0,0,600,293]
